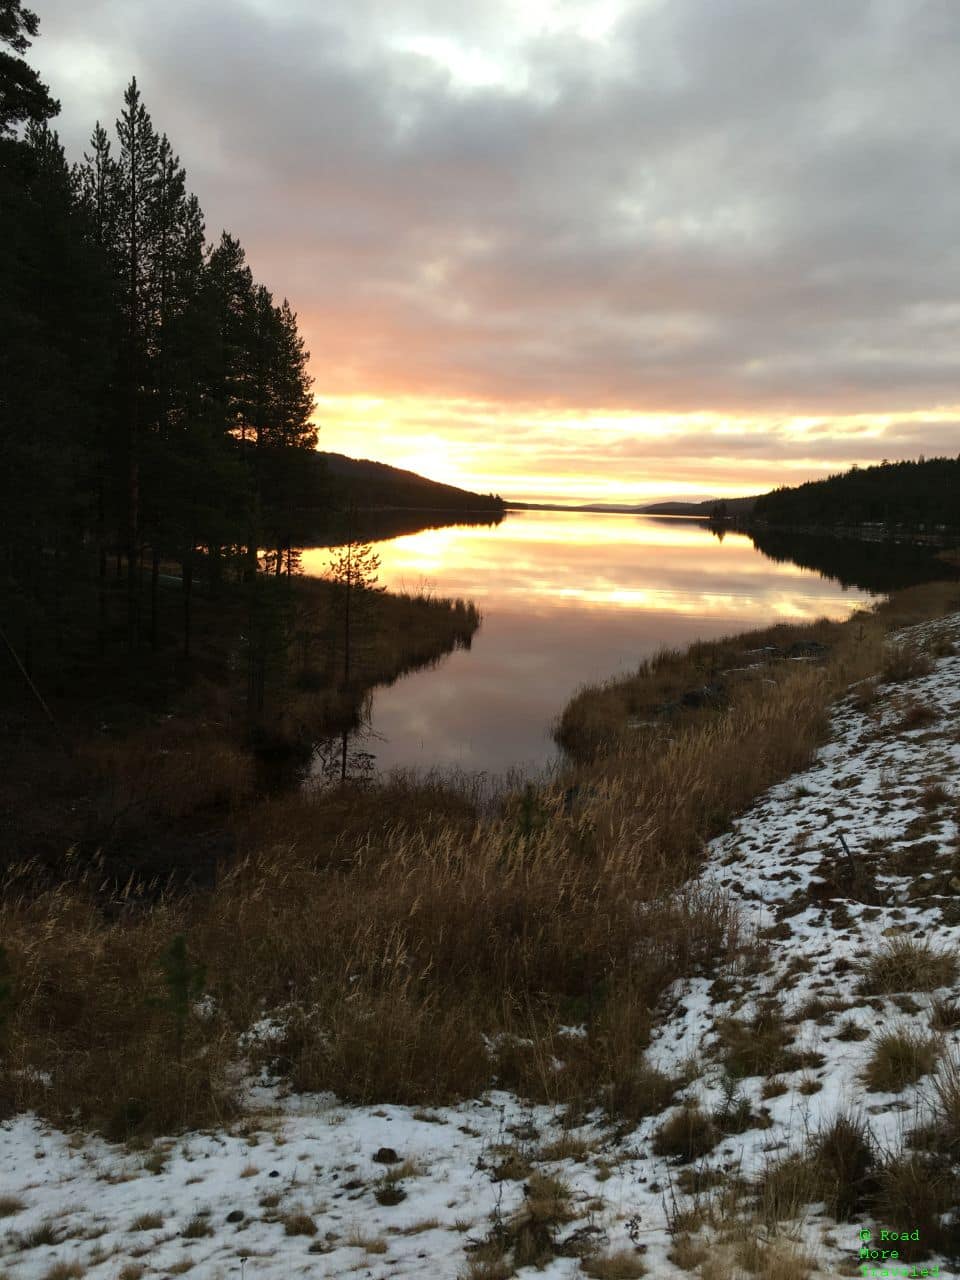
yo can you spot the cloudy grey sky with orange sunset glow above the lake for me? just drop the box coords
[28,0,960,502]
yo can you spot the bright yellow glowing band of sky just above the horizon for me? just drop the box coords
[309,394,960,504]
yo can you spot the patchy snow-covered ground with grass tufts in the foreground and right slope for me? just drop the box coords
[0,614,960,1280]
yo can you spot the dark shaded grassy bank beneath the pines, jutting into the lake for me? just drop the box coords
[0,577,480,900]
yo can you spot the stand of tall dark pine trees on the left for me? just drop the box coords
[0,4,319,667]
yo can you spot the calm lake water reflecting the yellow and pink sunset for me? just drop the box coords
[303,512,877,774]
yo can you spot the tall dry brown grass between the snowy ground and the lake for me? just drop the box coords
[0,584,960,1138]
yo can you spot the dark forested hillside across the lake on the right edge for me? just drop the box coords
[753,457,960,532]
